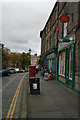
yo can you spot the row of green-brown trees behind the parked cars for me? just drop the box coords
[2,45,30,69]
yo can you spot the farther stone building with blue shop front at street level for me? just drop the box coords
[40,2,58,77]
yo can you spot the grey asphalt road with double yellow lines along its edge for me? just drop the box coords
[2,73,28,119]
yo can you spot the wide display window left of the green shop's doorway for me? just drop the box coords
[59,51,65,76]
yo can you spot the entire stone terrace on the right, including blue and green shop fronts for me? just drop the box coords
[40,2,80,92]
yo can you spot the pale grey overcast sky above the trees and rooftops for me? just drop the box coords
[0,0,56,55]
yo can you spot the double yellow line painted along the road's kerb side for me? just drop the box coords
[6,74,26,120]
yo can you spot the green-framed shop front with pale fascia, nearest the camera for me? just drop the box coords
[58,35,75,89]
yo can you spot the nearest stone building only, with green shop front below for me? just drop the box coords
[58,2,80,92]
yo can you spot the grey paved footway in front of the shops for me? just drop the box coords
[26,76,78,119]
